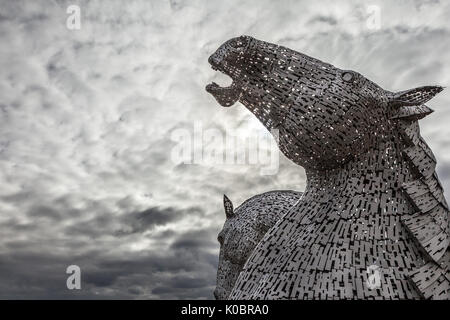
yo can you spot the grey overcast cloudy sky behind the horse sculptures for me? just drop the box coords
[0,0,450,299]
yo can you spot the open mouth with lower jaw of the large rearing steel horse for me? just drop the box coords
[205,59,242,107]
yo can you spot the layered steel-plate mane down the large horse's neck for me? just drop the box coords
[392,105,450,298]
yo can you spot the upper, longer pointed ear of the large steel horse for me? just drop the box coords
[389,86,444,107]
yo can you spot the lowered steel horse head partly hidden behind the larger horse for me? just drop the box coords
[214,190,302,300]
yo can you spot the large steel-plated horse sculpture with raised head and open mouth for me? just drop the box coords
[206,36,450,299]
